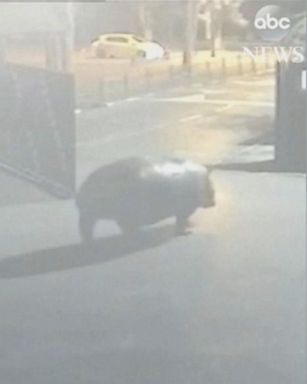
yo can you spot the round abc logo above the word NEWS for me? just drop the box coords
[254,5,291,41]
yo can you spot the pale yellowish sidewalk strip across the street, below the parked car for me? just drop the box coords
[74,51,275,107]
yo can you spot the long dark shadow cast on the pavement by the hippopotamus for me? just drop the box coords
[0,225,174,279]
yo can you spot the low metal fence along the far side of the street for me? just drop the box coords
[75,54,275,108]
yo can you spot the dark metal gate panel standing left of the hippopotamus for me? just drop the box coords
[0,64,76,198]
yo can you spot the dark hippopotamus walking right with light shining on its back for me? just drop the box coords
[76,158,215,242]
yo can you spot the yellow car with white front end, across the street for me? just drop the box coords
[91,33,168,60]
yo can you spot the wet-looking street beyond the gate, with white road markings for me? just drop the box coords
[77,72,275,180]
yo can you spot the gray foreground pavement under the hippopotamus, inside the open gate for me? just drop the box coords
[0,172,306,384]
